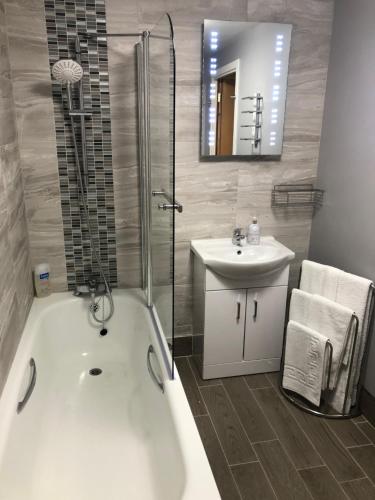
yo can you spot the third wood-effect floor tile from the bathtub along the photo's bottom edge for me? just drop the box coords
[254,441,312,500]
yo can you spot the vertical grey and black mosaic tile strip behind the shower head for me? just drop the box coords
[44,0,117,289]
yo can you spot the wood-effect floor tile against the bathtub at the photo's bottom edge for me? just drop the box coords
[195,416,241,500]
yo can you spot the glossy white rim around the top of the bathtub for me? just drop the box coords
[0,289,221,500]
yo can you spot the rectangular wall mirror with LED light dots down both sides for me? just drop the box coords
[201,19,292,160]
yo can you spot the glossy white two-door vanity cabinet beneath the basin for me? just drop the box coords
[193,255,289,379]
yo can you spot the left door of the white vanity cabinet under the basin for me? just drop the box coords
[204,290,246,365]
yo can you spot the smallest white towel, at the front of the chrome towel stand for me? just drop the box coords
[282,321,328,406]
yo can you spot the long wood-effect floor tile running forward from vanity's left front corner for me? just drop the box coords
[200,385,256,465]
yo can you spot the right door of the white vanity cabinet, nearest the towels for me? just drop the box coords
[244,286,288,361]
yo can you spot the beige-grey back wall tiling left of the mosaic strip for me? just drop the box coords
[5,0,67,291]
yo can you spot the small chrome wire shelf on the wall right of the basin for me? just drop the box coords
[271,184,324,209]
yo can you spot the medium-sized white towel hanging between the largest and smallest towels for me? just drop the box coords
[289,289,353,390]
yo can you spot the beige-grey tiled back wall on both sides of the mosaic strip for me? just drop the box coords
[2,0,333,342]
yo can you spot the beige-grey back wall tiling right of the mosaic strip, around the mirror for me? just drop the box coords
[106,0,333,335]
